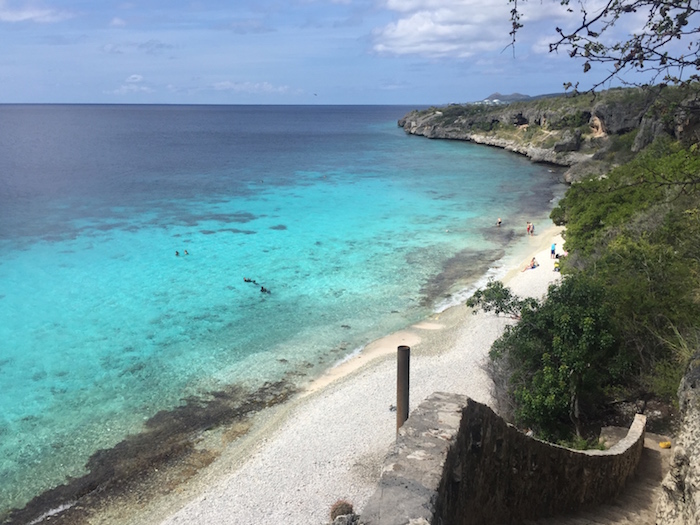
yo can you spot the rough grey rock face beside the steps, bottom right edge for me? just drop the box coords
[656,353,700,525]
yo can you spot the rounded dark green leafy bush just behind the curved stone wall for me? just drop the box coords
[468,274,624,439]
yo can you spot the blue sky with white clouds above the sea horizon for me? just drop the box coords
[0,0,652,104]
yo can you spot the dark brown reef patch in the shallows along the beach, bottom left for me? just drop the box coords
[0,380,296,525]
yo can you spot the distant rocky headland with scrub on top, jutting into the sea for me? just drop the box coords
[398,89,700,182]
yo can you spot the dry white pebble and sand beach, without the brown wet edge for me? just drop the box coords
[122,227,563,525]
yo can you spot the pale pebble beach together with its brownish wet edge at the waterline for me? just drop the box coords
[15,226,562,525]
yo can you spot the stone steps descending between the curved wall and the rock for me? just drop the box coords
[522,429,672,525]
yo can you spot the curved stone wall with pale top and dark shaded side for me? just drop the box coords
[361,393,646,525]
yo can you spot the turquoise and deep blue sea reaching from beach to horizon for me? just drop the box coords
[0,105,564,521]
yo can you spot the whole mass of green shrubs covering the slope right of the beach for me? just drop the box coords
[468,91,700,440]
